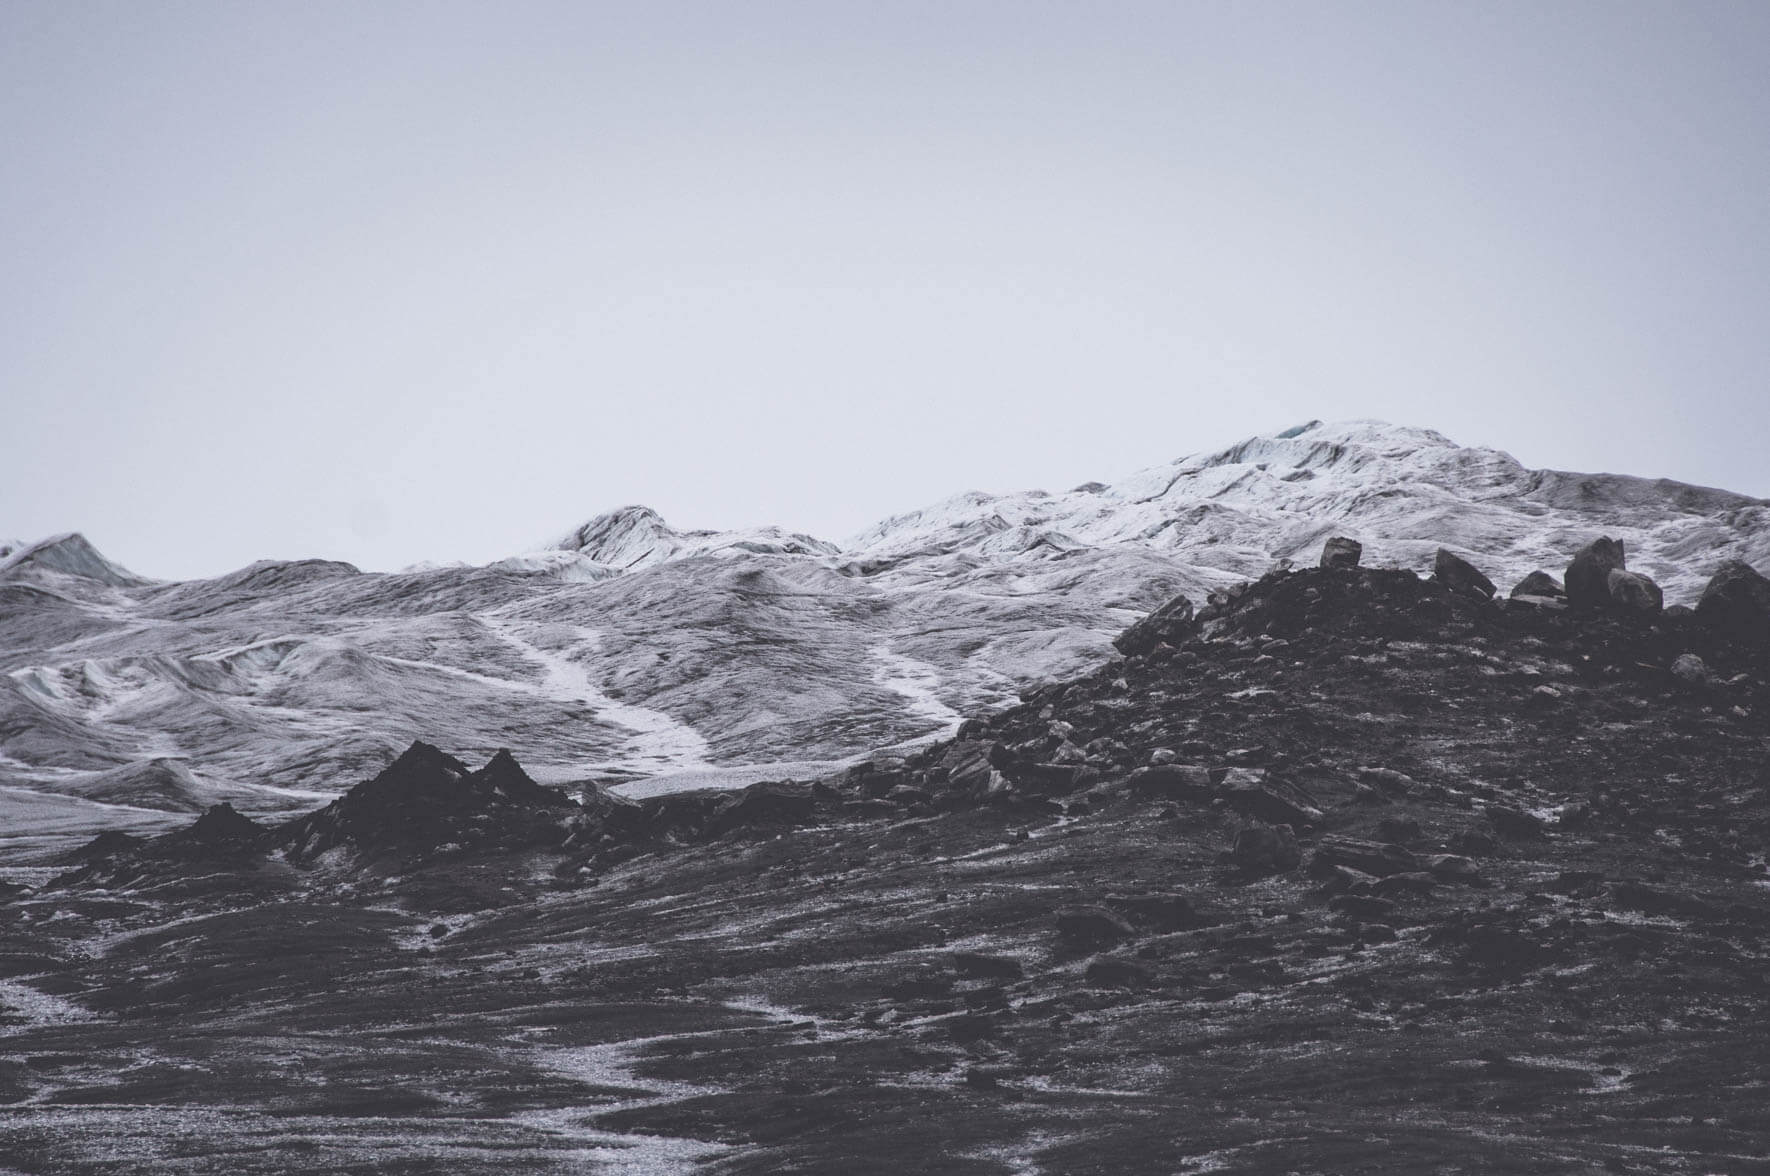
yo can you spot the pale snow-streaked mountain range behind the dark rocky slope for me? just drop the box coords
[0,422,1770,832]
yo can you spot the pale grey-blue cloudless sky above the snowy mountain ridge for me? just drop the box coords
[0,0,1770,577]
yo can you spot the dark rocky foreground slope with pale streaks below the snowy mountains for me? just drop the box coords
[0,570,1770,1176]
